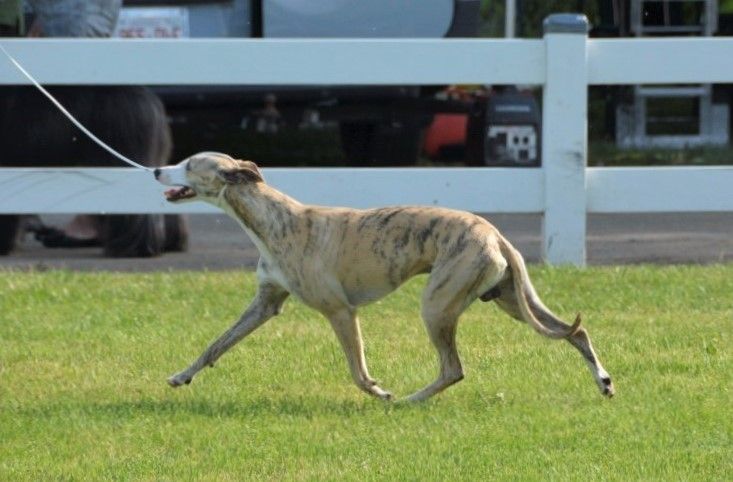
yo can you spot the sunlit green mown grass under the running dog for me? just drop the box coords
[0,265,733,481]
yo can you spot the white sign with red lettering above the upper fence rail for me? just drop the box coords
[113,7,189,38]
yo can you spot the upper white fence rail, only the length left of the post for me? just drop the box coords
[0,39,544,85]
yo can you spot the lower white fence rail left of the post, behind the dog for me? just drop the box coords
[0,168,544,214]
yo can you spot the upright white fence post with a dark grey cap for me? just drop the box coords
[542,14,588,266]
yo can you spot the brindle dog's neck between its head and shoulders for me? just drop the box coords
[219,182,303,252]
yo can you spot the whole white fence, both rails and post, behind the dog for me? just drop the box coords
[0,15,733,265]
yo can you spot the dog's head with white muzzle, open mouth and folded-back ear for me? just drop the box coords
[153,152,263,203]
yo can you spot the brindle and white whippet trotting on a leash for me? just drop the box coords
[154,152,614,401]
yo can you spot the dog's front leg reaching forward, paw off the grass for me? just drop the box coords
[168,284,289,388]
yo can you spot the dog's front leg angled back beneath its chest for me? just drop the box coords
[327,308,392,400]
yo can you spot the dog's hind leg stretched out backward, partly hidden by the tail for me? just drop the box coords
[496,280,615,397]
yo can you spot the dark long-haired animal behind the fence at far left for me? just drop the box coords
[0,86,187,257]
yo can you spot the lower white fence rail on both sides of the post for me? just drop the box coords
[0,167,733,214]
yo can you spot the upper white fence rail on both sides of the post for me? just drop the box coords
[5,37,733,85]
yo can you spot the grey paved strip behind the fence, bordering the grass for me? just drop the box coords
[0,213,733,271]
